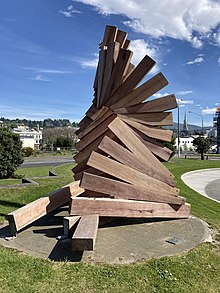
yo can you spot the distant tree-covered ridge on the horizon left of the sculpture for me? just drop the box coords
[0,117,78,128]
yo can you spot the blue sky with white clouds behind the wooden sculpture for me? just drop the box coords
[0,0,220,125]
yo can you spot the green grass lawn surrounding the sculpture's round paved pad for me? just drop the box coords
[0,158,220,293]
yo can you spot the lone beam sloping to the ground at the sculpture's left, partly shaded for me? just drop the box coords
[6,182,84,235]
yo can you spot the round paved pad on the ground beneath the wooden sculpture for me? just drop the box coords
[0,208,210,264]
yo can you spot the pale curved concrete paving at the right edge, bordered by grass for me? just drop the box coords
[181,168,220,203]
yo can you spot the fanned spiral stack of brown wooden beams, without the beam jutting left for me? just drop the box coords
[70,26,190,249]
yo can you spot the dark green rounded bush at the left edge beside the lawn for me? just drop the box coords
[0,129,24,179]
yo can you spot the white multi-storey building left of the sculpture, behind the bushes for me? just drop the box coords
[13,126,42,150]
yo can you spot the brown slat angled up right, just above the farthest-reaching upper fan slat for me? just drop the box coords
[111,69,168,112]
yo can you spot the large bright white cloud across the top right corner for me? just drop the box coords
[75,0,220,48]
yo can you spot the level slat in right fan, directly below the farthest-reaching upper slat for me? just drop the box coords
[118,112,173,126]
